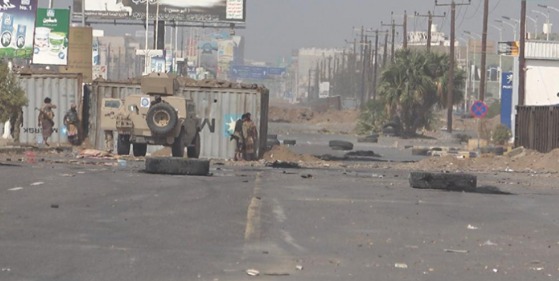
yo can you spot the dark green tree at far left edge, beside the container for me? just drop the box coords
[0,62,28,143]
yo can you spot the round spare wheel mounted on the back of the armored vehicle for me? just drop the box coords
[146,102,179,135]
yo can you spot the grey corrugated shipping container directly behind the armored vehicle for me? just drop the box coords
[88,81,269,159]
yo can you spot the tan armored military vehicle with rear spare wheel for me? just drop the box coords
[101,73,200,158]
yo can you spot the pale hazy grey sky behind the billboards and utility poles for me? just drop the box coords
[39,0,559,62]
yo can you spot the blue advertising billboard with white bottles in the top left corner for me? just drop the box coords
[0,0,38,59]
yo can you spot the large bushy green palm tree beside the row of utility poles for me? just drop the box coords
[358,50,466,136]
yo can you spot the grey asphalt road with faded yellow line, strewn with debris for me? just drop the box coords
[0,156,559,281]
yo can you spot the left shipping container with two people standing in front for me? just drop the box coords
[18,74,82,146]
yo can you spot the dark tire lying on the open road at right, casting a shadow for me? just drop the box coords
[410,172,477,192]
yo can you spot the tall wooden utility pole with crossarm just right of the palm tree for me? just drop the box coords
[435,0,471,133]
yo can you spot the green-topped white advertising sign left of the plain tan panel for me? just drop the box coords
[33,8,70,65]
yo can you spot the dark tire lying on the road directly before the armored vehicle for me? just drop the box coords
[145,157,210,176]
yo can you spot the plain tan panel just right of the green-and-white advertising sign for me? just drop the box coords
[60,27,93,83]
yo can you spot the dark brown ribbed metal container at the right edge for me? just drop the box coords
[514,106,559,153]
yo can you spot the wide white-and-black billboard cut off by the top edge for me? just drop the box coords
[73,0,246,22]
